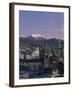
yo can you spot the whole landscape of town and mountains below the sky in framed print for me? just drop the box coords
[19,36,64,79]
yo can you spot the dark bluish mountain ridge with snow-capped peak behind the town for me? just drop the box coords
[19,35,64,48]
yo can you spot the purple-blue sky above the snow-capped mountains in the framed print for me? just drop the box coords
[19,10,64,39]
